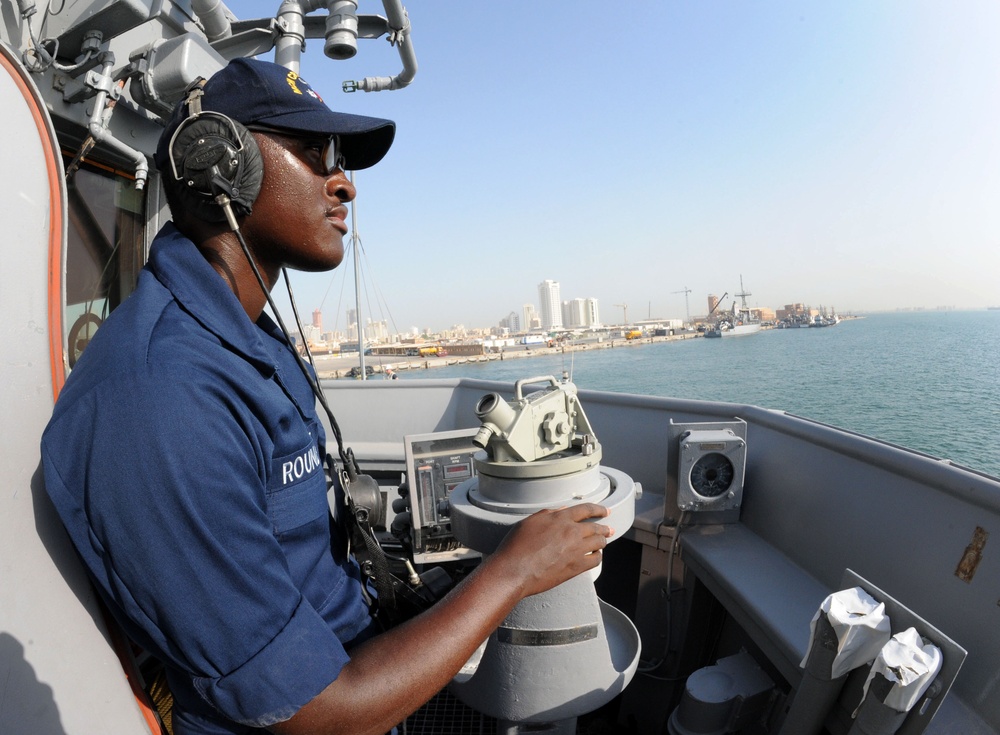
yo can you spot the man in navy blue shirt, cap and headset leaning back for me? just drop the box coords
[42,59,612,735]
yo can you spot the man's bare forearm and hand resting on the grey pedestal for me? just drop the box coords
[271,503,614,735]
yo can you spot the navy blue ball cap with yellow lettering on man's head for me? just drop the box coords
[154,58,396,171]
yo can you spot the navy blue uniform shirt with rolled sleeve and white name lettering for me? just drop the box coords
[42,225,372,733]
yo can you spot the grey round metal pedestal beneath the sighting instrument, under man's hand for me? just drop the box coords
[450,459,639,724]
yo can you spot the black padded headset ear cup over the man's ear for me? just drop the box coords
[170,112,264,222]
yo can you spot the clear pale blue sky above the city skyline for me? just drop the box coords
[242,0,1000,332]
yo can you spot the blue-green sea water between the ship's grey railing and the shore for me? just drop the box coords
[390,311,1000,476]
